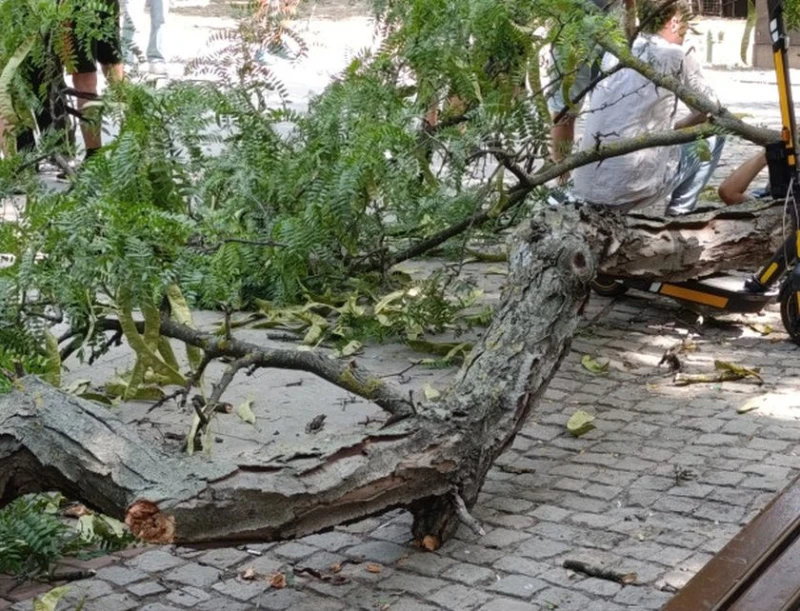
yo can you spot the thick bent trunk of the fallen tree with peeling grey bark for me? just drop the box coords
[0,200,778,545]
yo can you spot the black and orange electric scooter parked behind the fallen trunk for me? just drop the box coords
[592,0,800,344]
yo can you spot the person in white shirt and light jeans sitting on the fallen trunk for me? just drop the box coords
[573,0,724,215]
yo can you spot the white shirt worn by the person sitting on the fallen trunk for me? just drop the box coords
[574,35,716,207]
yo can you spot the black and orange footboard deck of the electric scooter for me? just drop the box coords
[623,275,778,313]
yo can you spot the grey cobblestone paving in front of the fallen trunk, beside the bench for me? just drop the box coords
[0,295,800,611]
